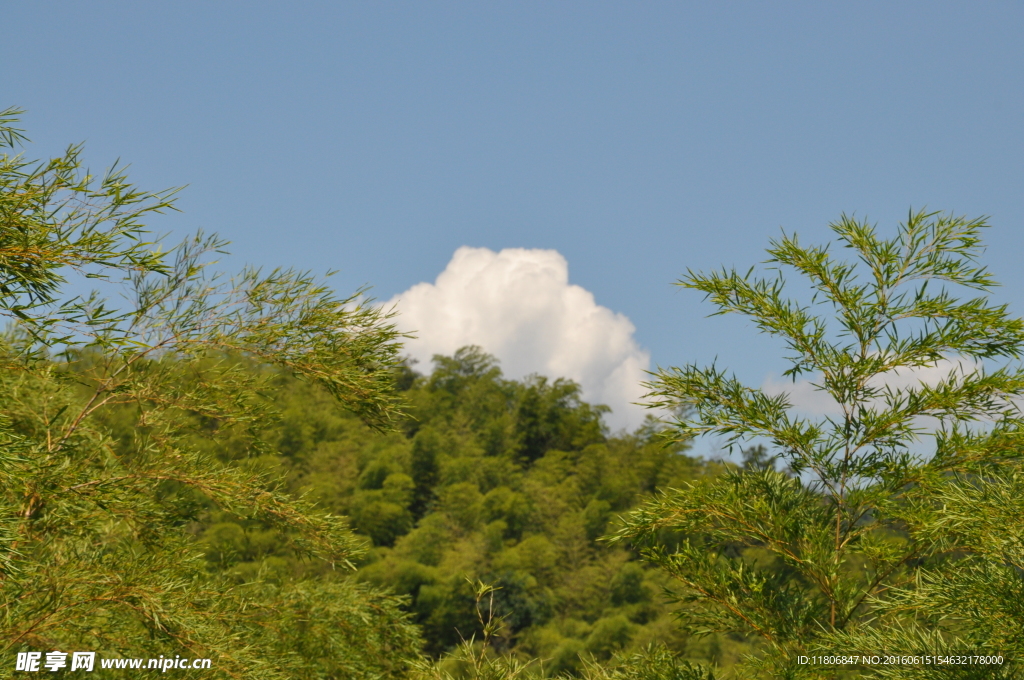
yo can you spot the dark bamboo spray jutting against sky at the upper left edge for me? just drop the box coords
[0,109,175,342]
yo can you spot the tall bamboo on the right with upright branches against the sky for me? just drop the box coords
[617,212,1024,678]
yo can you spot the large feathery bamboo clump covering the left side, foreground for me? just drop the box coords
[0,110,418,678]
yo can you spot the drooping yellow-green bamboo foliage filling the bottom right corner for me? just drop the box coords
[823,471,1024,679]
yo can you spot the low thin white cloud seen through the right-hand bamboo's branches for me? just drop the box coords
[761,358,981,416]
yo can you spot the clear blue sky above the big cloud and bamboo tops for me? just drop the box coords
[0,2,1024,430]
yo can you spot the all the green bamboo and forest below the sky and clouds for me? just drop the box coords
[0,111,1024,680]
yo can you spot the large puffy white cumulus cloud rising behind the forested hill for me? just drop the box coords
[388,247,650,428]
